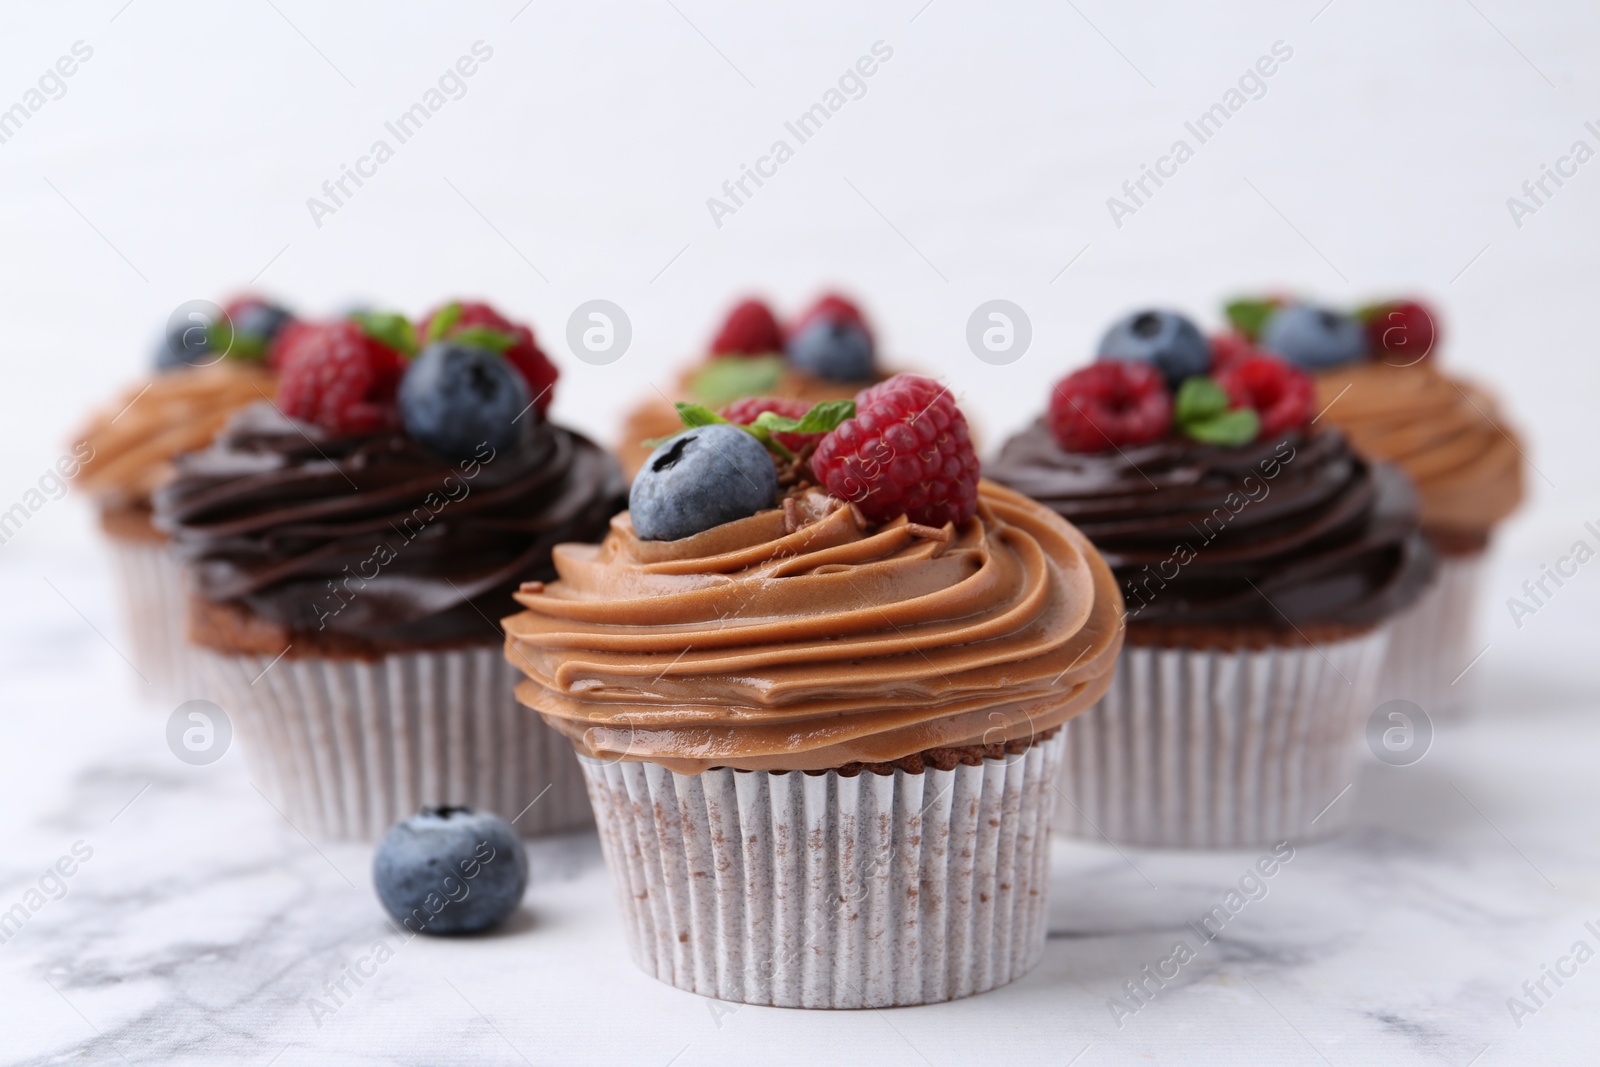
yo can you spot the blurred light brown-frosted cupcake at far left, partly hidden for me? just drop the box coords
[74,298,291,702]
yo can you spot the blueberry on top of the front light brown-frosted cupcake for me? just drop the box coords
[627,424,778,541]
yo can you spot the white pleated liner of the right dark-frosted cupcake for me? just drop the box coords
[1056,629,1387,848]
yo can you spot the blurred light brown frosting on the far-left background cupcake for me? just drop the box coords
[75,363,274,507]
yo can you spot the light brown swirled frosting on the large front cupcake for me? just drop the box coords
[506,483,1122,774]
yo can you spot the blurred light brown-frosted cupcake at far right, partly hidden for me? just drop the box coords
[1229,301,1523,713]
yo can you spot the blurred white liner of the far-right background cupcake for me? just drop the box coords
[1378,552,1485,715]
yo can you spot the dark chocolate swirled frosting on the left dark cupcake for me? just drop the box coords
[155,403,626,654]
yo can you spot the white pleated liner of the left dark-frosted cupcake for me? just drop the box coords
[202,645,592,841]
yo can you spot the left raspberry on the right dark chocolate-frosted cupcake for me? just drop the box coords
[1046,360,1173,453]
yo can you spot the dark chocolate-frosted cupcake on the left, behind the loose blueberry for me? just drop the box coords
[157,304,624,840]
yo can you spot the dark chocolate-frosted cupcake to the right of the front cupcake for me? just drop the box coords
[990,312,1434,848]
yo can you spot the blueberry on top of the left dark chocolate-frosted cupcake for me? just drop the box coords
[400,341,539,459]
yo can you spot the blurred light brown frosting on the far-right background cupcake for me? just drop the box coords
[1317,363,1522,537]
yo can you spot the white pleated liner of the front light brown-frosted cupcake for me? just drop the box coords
[582,734,1061,1008]
